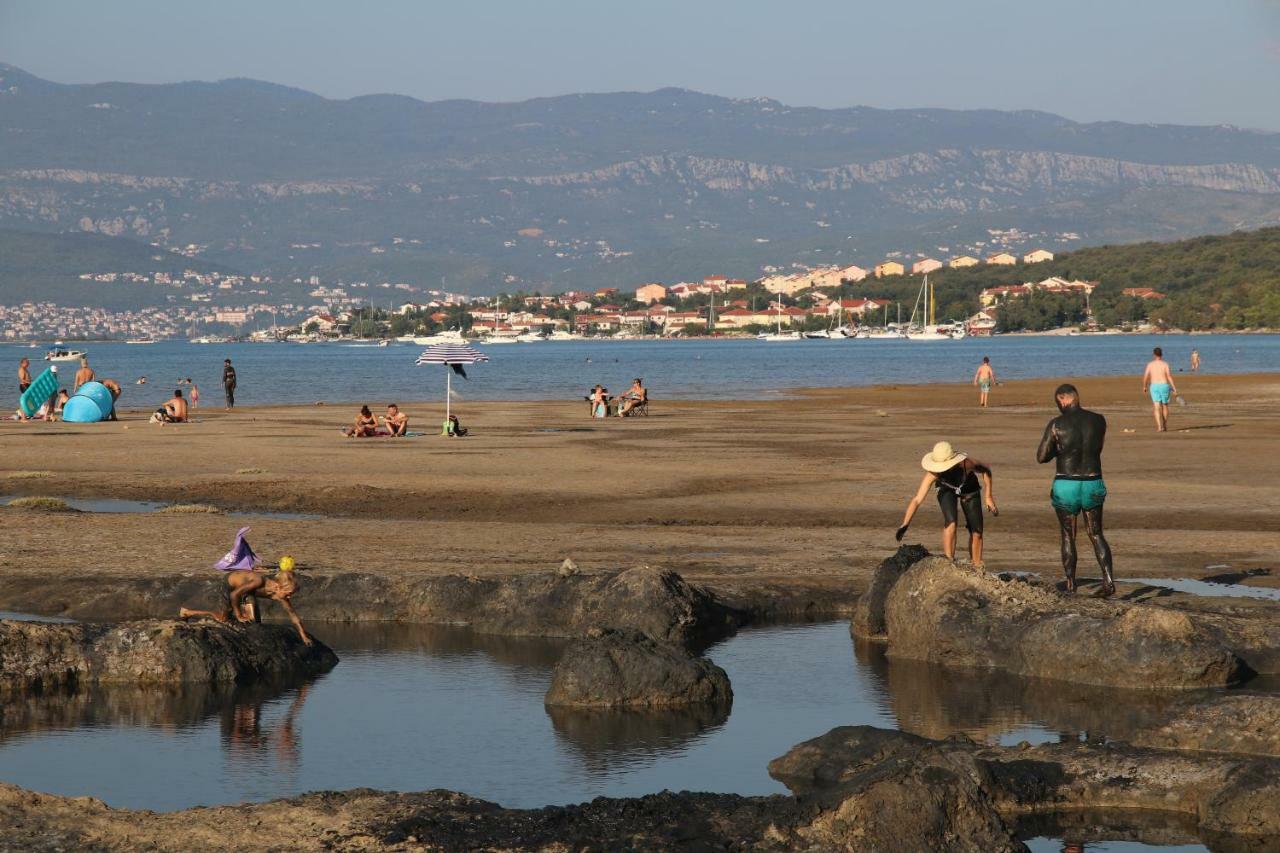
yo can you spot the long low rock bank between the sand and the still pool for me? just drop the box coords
[0,566,748,644]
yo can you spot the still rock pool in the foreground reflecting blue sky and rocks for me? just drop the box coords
[0,622,1264,849]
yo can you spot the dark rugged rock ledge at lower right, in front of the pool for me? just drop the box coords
[769,726,1280,849]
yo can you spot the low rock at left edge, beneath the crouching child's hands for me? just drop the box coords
[0,621,338,690]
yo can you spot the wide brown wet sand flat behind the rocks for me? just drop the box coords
[0,374,1280,610]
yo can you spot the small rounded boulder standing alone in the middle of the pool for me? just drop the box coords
[547,629,733,708]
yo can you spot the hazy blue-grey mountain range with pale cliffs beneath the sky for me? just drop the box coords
[0,64,1280,293]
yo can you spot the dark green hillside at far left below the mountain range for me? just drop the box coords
[0,229,234,309]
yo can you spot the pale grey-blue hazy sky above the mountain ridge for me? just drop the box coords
[0,0,1280,131]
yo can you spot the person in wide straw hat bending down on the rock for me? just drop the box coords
[896,442,1000,566]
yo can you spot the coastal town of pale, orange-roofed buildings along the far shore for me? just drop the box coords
[0,248,1164,342]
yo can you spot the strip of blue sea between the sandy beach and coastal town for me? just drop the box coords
[0,334,1280,409]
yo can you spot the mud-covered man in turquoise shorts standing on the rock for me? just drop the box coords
[1036,384,1116,596]
